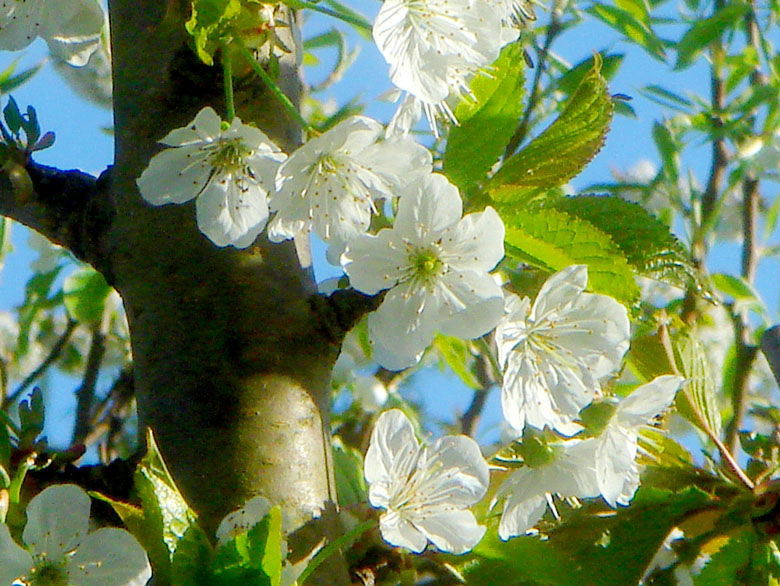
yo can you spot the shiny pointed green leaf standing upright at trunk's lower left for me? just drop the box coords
[135,430,201,574]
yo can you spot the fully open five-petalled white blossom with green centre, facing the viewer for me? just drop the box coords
[341,174,504,370]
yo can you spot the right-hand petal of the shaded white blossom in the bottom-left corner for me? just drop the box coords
[67,527,152,586]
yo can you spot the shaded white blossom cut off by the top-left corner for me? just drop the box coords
[0,0,104,66]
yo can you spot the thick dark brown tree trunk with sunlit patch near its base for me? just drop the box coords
[105,0,338,560]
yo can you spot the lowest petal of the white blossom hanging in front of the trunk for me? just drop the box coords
[196,175,268,248]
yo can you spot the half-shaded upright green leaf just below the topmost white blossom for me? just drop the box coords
[443,43,525,190]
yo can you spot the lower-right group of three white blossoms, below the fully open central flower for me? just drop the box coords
[365,266,684,553]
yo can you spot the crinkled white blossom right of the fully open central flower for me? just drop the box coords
[496,265,630,435]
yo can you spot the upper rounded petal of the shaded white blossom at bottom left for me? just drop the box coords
[22,484,90,561]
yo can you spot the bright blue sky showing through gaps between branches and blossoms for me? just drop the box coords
[0,0,780,443]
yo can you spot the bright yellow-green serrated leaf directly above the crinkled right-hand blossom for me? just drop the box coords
[504,208,639,305]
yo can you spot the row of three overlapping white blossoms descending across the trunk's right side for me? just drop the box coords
[138,108,504,370]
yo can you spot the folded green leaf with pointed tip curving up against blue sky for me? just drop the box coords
[487,56,613,203]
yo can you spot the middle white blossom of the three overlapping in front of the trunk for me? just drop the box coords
[268,116,432,250]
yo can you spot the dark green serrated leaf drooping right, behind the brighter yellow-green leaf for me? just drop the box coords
[552,195,698,289]
